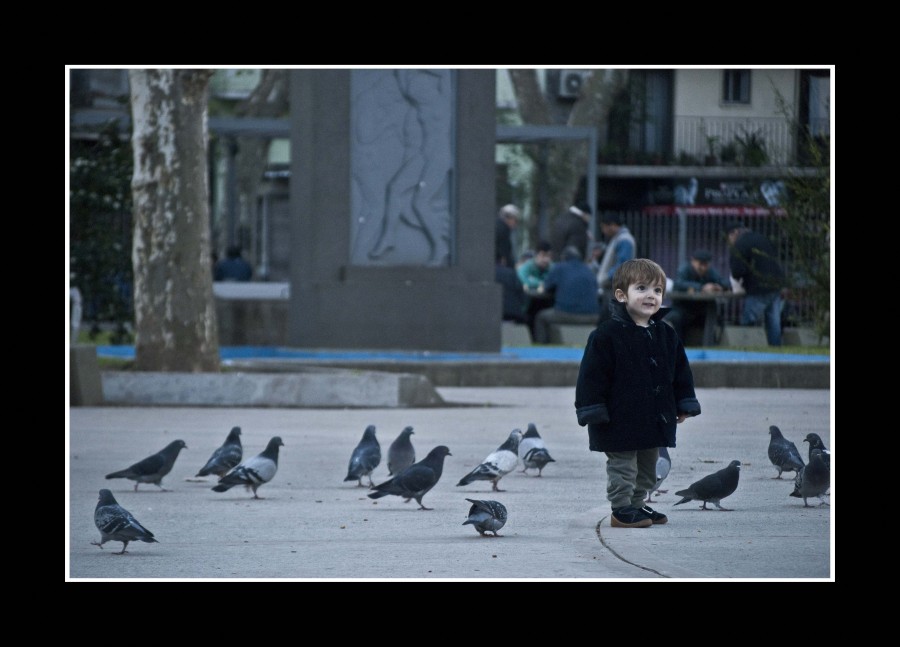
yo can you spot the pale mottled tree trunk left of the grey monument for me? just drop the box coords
[129,70,219,372]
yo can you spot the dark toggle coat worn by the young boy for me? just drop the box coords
[575,302,700,452]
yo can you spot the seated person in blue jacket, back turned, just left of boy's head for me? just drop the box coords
[534,245,600,344]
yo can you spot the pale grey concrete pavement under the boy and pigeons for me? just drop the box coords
[66,387,835,581]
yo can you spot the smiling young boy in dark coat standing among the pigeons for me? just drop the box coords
[575,258,700,528]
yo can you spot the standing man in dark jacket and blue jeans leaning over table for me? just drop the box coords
[725,221,785,346]
